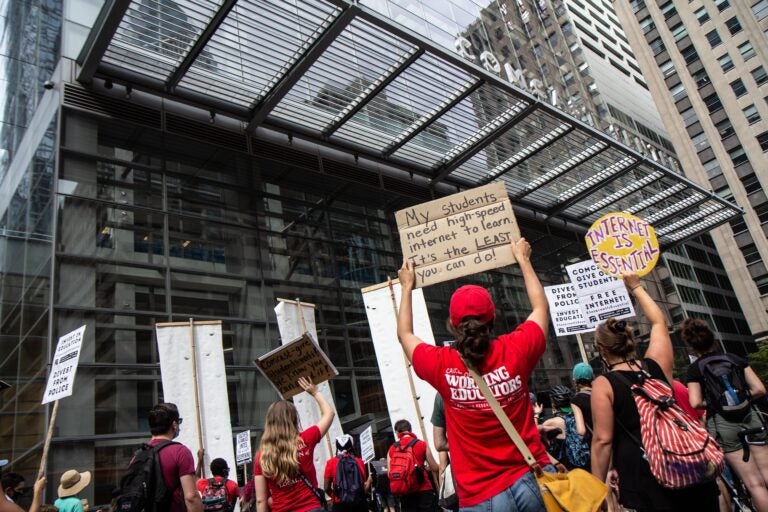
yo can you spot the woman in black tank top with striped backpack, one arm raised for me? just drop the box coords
[591,274,722,512]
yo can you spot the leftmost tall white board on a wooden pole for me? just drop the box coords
[155,320,236,482]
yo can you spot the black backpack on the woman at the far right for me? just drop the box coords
[697,354,750,421]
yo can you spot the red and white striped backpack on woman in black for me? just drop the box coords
[614,365,725,489]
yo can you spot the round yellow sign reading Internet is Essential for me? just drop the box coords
[584,212,659,277]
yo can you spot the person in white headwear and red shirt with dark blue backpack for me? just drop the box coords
[323,434,371,512]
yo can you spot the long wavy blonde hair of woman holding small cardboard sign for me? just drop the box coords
[259,400,301,483]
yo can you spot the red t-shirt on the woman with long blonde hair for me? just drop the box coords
[253,425,321,512]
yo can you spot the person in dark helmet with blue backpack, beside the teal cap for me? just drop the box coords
[540,385,590,469]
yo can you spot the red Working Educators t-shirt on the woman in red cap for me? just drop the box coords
[413,321,549,507]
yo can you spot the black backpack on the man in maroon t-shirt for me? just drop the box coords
[115,441,179,512]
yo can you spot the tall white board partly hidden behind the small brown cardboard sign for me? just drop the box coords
[275,299,344,482]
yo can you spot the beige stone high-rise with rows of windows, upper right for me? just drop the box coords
[614,0,768,339]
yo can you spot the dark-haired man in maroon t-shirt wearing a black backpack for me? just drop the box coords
[115,402,203,512]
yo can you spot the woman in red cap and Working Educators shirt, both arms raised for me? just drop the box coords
[397,238,554,511]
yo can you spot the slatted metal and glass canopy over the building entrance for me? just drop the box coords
[78,0,742,246]
